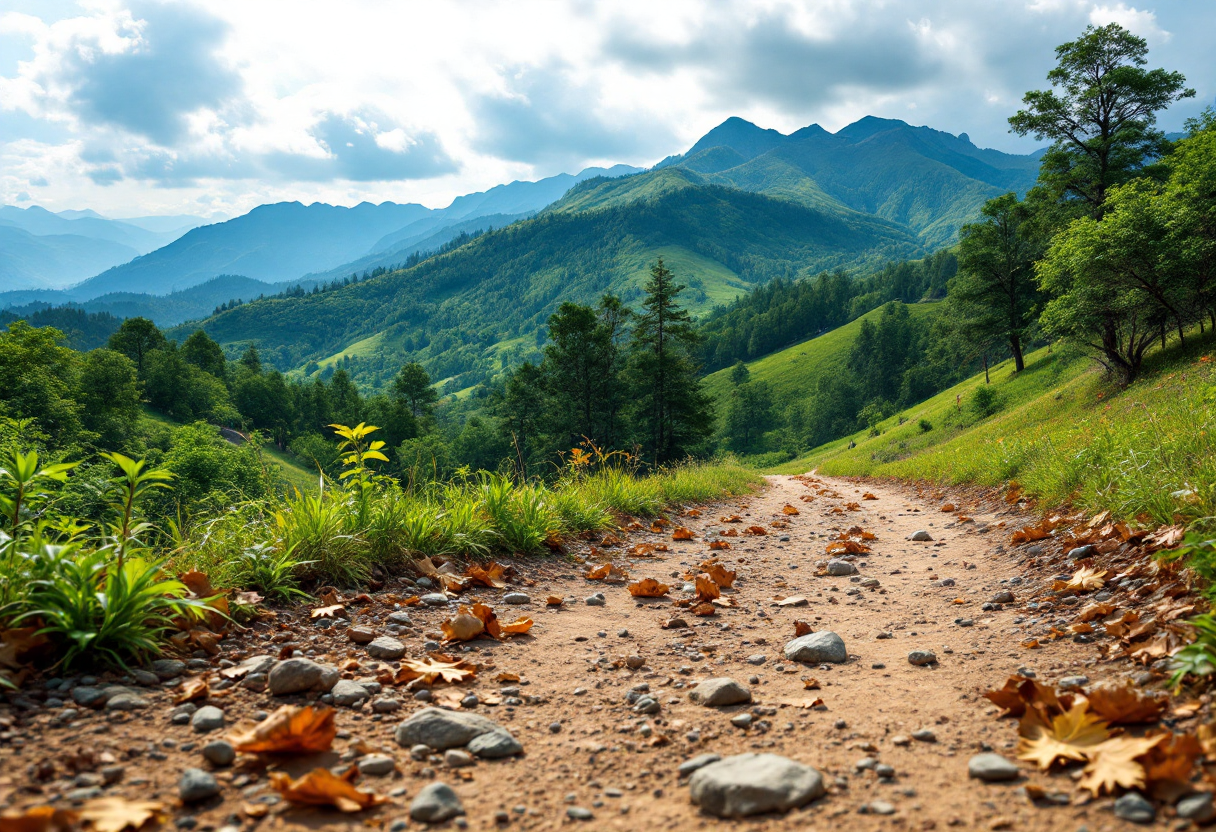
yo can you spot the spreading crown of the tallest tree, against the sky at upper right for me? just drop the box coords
[1009,23,1195,217]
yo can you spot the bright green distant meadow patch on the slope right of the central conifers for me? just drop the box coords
[704,303,940,401]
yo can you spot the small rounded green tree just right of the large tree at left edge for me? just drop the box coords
[77,349,140,450]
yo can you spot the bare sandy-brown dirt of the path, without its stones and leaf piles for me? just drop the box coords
[0,477,1147,830]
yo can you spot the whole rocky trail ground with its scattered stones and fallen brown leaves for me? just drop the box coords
[0,477,1211,832]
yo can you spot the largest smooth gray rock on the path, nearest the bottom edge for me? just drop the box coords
[688,754,826,817]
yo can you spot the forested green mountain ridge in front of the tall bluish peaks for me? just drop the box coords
[174,183,921,386]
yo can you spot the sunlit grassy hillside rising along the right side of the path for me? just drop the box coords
[777,333,1216,525]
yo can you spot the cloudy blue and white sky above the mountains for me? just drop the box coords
[0,0,1216,215]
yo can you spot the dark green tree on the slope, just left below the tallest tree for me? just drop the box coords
[948,193,1042,372]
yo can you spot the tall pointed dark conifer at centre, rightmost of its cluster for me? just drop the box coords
[630,258,714,465]
